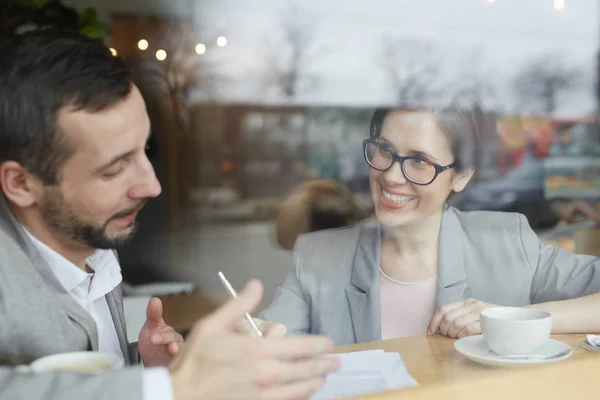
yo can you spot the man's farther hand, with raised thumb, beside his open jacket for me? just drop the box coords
[138,297,183,367]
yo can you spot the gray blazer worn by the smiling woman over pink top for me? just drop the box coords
[260,207,600,345]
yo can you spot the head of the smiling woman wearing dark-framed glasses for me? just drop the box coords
[363,108,480,227]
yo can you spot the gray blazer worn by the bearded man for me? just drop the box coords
[0,193,142,400]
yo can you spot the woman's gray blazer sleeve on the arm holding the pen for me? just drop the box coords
[259,241,310,335]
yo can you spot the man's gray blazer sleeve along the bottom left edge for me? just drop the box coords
[0,366,143,400]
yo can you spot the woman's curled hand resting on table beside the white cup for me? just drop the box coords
[427,299,496,338]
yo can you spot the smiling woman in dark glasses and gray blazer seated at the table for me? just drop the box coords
[261,108,600,345]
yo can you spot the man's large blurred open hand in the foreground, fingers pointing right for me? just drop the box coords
[169,281,339,400]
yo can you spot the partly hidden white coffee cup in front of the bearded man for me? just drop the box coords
[29,351,124,374]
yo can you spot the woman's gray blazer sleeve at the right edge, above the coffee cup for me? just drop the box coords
[519,215,600,304]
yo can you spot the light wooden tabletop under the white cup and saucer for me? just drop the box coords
[336,335,600,400]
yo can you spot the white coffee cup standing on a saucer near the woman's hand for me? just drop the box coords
[480,307,552,355]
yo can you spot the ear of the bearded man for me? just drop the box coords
[0,161,42,208]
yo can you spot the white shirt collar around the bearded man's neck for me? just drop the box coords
[23,227,123,301]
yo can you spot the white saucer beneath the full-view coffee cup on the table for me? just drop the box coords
[454,335,573,367]
